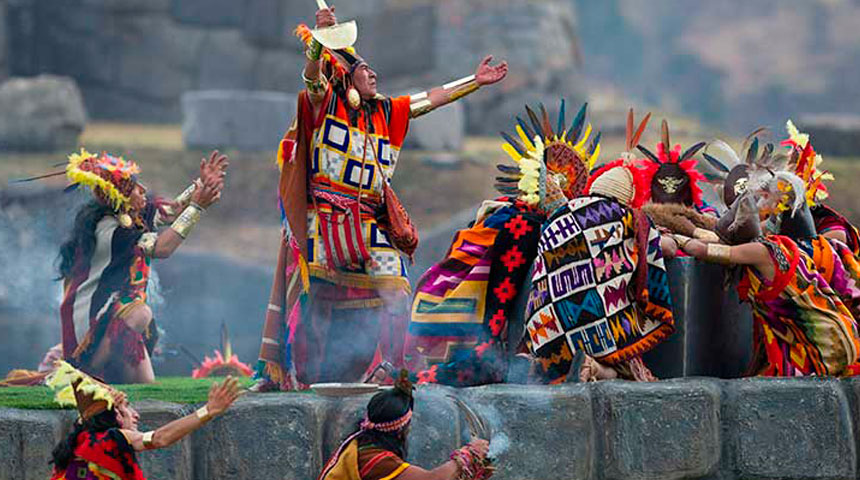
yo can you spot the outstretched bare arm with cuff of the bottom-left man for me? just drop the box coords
[122,377,239,451]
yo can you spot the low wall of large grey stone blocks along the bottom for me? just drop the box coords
[0,378,860,480]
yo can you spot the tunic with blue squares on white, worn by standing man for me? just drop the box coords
[307,86,409,290]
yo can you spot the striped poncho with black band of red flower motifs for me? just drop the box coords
[407,198,543,386]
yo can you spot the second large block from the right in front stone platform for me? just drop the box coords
[592,380,720,480]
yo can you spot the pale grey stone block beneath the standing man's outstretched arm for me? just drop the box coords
[404,103,466,151]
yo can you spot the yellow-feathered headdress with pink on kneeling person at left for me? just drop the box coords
[66,148,140,212]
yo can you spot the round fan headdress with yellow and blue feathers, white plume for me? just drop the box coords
[496,100,600,206]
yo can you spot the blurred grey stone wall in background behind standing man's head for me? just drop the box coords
[3,0,580,133]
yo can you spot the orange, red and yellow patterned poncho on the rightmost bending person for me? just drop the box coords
[738,235,860,376]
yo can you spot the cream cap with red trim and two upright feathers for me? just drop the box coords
[585,108,651,208]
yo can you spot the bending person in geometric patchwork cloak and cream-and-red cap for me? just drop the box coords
[524,121,677,383]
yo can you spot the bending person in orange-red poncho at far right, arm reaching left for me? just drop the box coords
[678,169,860,376]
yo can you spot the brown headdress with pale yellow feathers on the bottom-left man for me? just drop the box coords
[45,360,126,421]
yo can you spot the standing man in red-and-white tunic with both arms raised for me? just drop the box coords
[257,4,508,390]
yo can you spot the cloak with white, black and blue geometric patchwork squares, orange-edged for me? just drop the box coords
[525,196,674,383]
